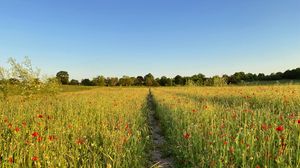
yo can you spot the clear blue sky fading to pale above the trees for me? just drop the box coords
[0,0,300,79]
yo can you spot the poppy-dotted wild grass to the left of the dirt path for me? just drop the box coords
[0,89,150,167]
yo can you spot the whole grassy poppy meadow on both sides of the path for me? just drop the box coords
[0,85,300,168]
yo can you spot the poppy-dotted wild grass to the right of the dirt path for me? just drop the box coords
[153,86,300,167]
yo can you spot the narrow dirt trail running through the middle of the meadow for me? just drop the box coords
[148,89,174,168]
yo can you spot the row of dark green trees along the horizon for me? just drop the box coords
[56,68,300,86]
